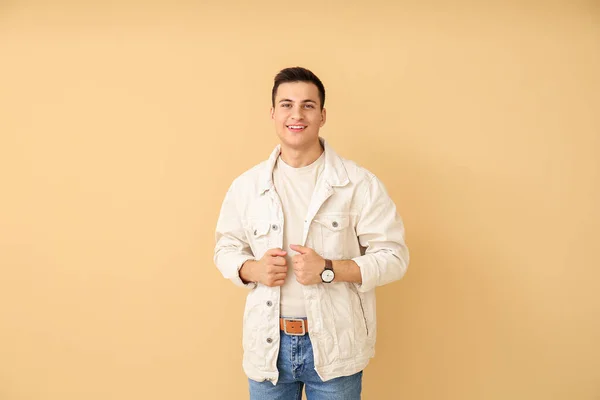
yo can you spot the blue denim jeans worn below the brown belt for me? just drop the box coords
[248,332,362,400]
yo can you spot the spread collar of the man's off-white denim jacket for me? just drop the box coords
[260,137,350,194]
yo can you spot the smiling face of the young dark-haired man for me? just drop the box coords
[271,82,325,150]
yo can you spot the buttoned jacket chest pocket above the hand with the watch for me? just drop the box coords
[314,215,353,260]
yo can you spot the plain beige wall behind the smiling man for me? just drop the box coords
[0,0,600,400]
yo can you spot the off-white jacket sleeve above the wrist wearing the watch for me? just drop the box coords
[353,176,409,292]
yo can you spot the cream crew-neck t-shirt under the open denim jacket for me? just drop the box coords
[273,152,325,318]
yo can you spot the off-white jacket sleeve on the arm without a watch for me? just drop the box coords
[214,181,256,289]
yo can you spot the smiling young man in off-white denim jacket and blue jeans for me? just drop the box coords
[214,67,408,400]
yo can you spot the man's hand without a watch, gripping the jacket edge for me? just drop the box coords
[240,248,288,287]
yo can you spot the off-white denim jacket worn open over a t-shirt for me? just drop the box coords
[214,139,408,384]
